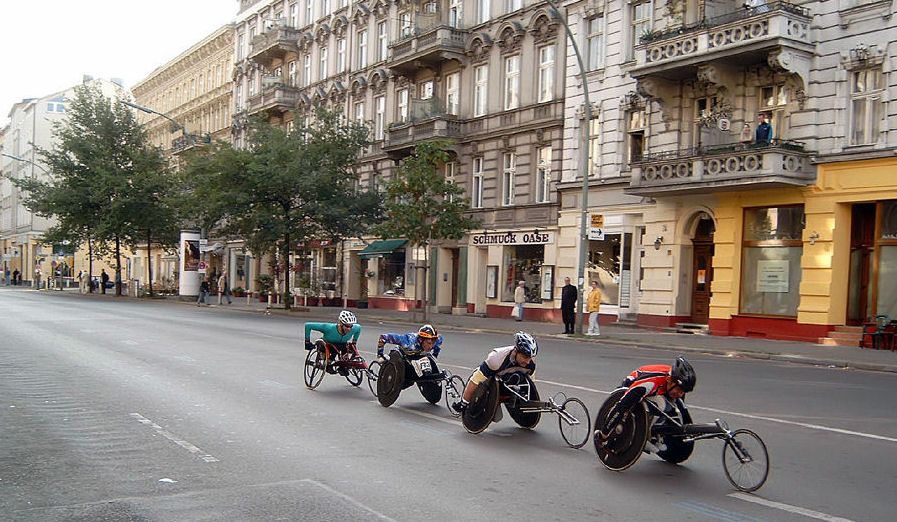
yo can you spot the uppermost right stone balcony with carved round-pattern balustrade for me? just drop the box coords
[629,2,814,80]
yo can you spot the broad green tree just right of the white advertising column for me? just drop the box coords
[184,107,381,307]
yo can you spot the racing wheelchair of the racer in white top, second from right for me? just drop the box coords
[461,372,591,448]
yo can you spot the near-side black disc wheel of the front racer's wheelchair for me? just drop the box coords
[594,388,648,471]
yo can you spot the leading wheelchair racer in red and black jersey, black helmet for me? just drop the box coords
[595,357,697,446]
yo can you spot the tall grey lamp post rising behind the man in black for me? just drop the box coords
[548,0,592,334]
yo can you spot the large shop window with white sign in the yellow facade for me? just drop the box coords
[741,206,805,316]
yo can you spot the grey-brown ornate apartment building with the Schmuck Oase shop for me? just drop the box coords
[234,0,565,312]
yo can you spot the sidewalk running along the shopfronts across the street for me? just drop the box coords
[45,284,897,373]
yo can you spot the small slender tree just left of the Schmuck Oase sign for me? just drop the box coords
[374,140,480,320]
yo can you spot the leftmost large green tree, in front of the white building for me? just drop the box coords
[14,85,176,295]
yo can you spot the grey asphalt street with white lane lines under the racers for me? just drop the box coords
[0,287,897,522]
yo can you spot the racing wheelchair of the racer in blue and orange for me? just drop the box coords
[368,347,464,416]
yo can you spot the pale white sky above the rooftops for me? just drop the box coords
[0,0,239,128]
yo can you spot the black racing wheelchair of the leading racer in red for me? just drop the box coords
[595,388,769,493]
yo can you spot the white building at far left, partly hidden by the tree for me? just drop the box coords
[0,76,128,285]
